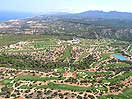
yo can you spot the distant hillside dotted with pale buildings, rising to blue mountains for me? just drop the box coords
[0,11,132,41]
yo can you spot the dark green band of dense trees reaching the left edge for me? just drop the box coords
[0,54,68,71]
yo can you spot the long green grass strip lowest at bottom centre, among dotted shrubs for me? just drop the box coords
[20,82,107,92]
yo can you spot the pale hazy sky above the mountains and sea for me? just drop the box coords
[0,0,132,13]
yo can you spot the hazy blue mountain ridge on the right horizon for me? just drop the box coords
[75,10,132,20]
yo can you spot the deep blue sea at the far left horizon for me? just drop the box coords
[0,11,35,21]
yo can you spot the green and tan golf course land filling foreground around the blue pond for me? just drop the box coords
[0,34,132,99]
